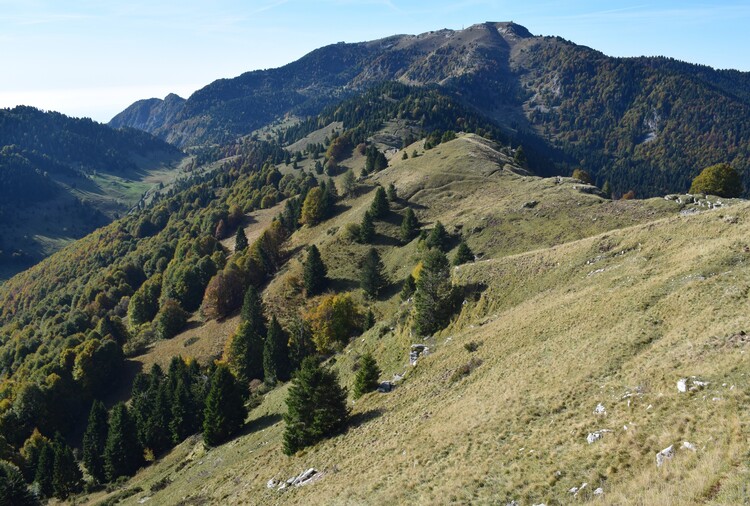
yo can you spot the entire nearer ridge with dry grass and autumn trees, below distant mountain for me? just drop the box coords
[0,81,750,504]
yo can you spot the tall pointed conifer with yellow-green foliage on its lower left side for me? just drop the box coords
[225,285,266,385]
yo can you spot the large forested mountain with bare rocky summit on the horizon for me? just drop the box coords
[111,23,750,197]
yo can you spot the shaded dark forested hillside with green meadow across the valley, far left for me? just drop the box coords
[0,107,183,280]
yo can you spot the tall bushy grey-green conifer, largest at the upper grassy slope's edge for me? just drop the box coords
[414,249,454,336]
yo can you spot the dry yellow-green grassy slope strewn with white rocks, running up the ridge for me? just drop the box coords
[83,138,750,504]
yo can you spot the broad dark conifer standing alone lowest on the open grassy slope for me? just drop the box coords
[284,357,349,455]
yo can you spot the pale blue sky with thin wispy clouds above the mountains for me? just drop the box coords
[0,0,750,121]
